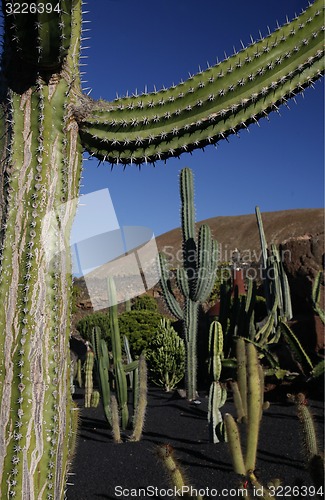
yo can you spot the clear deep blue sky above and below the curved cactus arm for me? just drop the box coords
[82,0,324,235]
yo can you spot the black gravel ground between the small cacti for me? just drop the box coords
[67,388,324,500]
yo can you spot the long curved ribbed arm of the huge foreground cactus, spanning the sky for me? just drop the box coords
[79,0,324,164]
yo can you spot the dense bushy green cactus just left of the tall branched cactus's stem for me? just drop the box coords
[146,318,185,392]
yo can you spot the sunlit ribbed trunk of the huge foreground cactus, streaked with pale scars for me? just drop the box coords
[0,1,81,500]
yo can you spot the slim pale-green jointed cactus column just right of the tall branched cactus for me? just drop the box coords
[208,321,227,443]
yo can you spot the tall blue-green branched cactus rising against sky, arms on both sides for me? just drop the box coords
[159,168,218,400]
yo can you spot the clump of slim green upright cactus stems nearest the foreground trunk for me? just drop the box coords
[92,278,147,442]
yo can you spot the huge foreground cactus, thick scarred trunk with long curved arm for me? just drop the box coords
[0,0,324,500]
